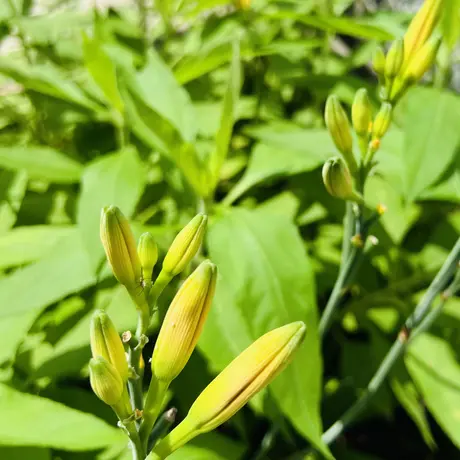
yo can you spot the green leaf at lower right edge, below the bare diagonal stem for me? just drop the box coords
[405,334,460,447]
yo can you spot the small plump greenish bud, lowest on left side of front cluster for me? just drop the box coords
[89,356,124,406]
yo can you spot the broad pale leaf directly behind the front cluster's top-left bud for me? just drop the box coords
[77,147,146,270]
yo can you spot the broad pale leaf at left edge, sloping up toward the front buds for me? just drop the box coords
[0,233,96,363]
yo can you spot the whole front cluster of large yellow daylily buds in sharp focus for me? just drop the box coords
[89,206,305,459]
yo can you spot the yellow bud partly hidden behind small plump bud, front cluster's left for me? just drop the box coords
[90,310,128,382]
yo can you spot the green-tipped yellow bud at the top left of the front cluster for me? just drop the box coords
[100,206,141,289]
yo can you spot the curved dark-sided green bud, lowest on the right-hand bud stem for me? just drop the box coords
[322,157,362,202]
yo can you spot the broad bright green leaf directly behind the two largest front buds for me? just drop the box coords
[200,208,328,456]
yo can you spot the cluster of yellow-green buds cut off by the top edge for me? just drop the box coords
[372,0,443,104]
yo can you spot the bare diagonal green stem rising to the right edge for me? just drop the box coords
[322,238,460,444]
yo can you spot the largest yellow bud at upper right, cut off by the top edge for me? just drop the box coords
[404,0,443,69]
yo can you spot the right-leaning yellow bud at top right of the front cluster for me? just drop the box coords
[163,214,208,276]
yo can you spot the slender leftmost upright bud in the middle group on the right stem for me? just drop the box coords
[324,94,357,171]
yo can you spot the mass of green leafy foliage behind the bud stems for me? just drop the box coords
[0,0,460,460]
